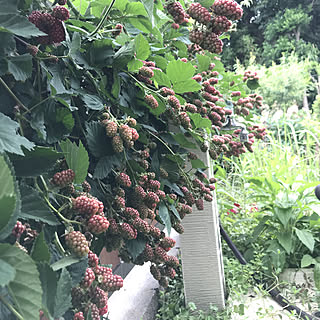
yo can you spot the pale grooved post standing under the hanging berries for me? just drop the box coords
[180,148,225,310]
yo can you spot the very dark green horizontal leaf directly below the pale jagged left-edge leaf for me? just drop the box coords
[10,146,62,177]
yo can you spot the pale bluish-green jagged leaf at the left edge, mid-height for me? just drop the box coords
[0,113,34,156]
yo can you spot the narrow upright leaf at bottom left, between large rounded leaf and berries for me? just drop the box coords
[37,263,58,315]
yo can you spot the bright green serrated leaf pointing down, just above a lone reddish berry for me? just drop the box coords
[60,140,89,183]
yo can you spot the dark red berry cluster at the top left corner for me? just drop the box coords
[28,6,70,45]
